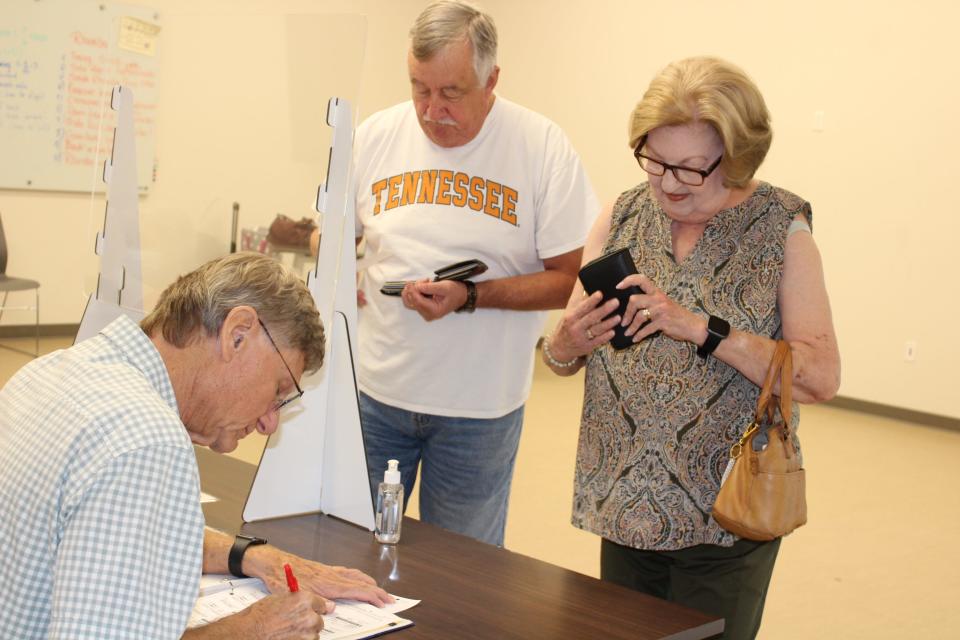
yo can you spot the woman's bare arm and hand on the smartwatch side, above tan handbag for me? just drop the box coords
[620,216,840,403]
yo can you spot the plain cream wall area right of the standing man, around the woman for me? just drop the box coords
[489,0,960,417]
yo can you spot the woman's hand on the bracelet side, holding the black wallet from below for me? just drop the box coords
[550,291,620,362]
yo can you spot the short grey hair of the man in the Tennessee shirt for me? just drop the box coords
[410,0,497,86]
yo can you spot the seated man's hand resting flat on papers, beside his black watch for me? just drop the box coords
[243,544,393,607]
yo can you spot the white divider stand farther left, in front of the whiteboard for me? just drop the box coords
[74,86,144,344]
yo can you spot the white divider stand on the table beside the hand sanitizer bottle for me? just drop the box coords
[243,98,374,531]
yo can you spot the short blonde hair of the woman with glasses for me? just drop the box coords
[629,56,773,187]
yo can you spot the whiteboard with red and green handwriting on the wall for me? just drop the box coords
[0,0,160,194]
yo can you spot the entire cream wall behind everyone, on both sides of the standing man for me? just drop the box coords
[0,0,960,417]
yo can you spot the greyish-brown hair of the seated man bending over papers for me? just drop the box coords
[140,252,324,371]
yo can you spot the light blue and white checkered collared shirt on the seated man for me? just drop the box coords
[0,317,203,640]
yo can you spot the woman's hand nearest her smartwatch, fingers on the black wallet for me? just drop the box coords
[617,274,707,345]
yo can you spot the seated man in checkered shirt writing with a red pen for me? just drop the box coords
[0,253,390,640]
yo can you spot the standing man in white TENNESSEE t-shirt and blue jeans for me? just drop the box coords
[354,2,599,545]
